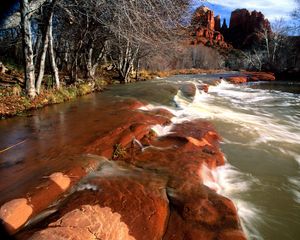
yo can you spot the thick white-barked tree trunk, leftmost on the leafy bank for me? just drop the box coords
[20,0,36,98]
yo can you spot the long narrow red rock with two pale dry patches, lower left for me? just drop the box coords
[0,159,98,233]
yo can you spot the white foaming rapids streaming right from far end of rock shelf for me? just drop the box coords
[174,81,300,144]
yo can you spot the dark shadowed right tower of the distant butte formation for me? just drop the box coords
[221,9,271,49]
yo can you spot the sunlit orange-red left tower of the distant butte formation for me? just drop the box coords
[191,6,230,48]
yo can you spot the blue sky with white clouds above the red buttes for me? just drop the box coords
[194,0,296,24]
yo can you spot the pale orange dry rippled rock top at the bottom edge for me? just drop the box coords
[30,205,135,240]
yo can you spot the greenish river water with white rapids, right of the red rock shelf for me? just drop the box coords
[105,75,300,240]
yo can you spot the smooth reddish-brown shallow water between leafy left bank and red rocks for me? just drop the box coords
[0,94,145,204]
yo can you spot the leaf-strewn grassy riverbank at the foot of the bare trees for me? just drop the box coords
[0,67,224,119]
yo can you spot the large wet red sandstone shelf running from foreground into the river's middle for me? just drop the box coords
[0,96,246,240]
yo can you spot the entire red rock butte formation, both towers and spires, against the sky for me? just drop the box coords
[191,6,271,49]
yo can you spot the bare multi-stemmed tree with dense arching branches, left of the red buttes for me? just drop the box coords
[104,0,189,82]
